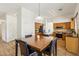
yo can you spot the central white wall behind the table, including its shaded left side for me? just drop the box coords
[17,8,35,38]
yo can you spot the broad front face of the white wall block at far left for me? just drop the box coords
[6,14,17,42]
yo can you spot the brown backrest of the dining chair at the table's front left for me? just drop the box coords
[18,40,29,56]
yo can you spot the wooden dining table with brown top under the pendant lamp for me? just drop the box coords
[16,36,57,55]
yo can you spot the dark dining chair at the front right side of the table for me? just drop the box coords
[43,38,57,56]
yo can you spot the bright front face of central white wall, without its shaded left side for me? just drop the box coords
[21,8,34,37]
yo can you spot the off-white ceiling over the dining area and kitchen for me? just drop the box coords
[0,3,77,18]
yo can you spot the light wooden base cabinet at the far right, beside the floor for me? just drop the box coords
[66,37,79,55]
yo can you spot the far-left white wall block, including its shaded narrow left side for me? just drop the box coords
[2,14,17,42]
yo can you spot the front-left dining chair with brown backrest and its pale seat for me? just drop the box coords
[18,40,38,56]
